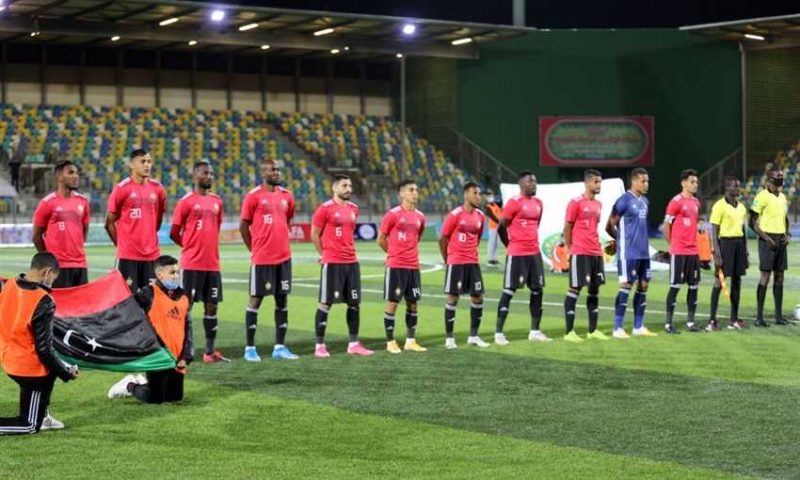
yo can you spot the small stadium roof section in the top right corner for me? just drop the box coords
[681,13,800,50]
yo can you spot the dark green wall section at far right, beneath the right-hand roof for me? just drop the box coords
[745,49,800,165]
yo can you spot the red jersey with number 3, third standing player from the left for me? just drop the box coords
[172,192,223,272]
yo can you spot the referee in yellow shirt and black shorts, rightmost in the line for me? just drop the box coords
[750,166,790,327]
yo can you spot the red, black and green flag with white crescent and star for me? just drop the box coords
[53,270,175,372]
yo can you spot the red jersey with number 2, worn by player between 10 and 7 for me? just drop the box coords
[503,195,542,256]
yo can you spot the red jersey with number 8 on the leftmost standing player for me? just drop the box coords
[33,192,89,268]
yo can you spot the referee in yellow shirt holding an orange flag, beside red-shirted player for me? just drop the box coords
[706,176,749,331]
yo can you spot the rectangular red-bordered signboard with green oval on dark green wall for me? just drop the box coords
[539,116,654,168]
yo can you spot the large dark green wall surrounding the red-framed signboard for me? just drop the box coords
[455,30,741,216]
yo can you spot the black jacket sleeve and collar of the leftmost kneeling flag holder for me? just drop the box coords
[0,273,72,382]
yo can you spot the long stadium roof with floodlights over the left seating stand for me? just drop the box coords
[0,0,534,59]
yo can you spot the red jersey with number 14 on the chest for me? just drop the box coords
[381,206,425,269]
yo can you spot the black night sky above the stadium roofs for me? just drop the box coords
[198,0,800,28]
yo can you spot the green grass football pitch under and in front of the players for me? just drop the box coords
[0,242,800,480]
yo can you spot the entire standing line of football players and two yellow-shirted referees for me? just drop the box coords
[34,155,788,361]
